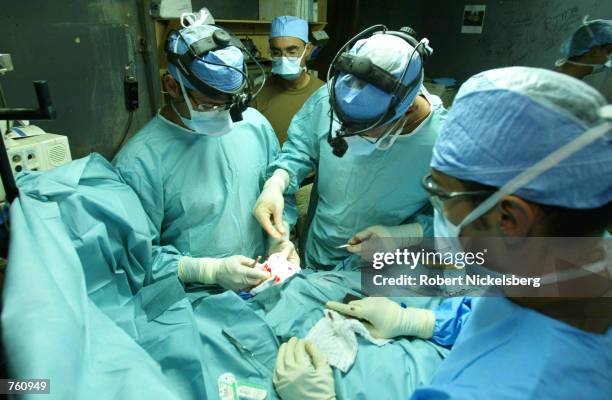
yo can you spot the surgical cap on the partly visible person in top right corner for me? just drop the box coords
[561,18,612,59]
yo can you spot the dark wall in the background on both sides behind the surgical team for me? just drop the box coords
[0,0,612,158]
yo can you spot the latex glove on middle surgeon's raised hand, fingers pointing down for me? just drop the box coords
[253,169,289,240]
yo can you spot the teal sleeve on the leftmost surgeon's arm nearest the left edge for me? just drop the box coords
[113,153,181,285]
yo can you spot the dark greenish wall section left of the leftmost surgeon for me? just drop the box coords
[0,0,159,158]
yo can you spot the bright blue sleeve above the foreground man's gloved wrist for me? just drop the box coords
[432,297,473,346]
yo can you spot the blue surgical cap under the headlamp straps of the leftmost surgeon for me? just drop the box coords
[168,25,244,92]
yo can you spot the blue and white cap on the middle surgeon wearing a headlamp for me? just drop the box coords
[335,34,423,123]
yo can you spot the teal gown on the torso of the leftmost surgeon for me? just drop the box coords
[114,108,279,258]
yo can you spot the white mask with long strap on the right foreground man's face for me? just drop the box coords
[434,105,612,283]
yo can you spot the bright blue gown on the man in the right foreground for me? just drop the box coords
[412,297,612,400]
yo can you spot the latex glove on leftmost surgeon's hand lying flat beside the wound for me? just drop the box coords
[178,256,270,290]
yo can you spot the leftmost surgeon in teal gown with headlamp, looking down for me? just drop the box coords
[114,14,298,289]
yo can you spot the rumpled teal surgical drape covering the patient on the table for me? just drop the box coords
[1,154,448,400]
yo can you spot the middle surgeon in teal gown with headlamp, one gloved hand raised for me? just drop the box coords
[254,28,446,269]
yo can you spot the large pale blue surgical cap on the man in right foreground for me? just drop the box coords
[431,67,612,209]
